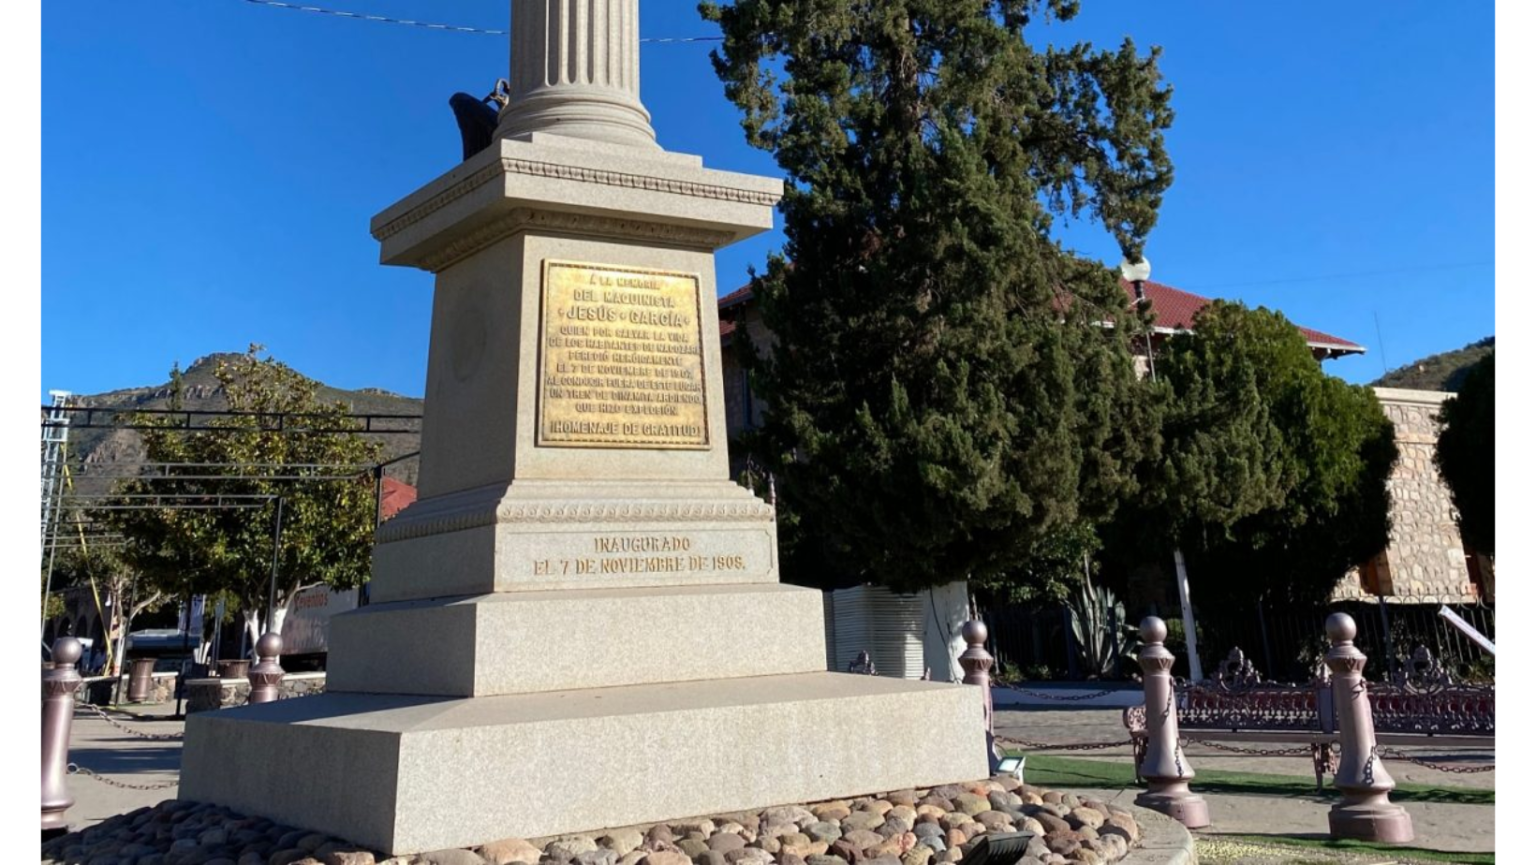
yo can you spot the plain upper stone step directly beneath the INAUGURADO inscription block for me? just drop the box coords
[327,582,826,698]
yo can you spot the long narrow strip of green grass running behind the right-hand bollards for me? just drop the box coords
[1025,754,1493,805]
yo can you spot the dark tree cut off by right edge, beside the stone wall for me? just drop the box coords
[1435,352,1493,556]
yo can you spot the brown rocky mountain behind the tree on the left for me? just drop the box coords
[53,353,422,493]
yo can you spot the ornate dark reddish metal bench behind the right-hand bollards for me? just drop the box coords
[1123,645,1493,791]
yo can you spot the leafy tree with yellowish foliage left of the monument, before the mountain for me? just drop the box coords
[112,346,379,645]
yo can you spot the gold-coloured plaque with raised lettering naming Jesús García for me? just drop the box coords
[538,261,710,450]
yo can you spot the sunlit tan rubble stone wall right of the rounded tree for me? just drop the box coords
[1335,387,1493,604]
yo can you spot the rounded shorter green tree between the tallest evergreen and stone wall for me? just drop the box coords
[1118,301,1398,605]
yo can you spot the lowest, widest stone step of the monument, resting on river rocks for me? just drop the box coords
[180,673,988,854]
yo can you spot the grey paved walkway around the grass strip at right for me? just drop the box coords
[995,707,1496,853]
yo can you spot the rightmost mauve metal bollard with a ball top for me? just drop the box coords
[1324,613,1413,843]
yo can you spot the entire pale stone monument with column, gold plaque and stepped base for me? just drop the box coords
[180,0,988,854]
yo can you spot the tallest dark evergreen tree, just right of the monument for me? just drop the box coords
[700,0,1172,593]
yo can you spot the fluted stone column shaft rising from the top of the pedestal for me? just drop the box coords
[496,0,660,151]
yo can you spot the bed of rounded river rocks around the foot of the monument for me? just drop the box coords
[41,777,1193,865]
